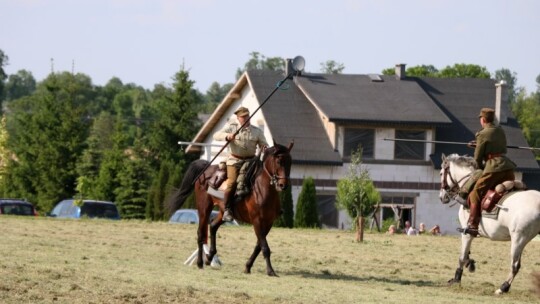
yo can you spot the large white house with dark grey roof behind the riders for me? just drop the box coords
[187,61,540,233]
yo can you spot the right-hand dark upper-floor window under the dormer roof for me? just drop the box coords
[394,130,426,160]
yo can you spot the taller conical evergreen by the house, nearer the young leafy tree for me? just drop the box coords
[294,177,321,228]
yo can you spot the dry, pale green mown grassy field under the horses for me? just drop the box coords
[0,216,540,304]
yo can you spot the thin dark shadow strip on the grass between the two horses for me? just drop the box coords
[281,270,438,287]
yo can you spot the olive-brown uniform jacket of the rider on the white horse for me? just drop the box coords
[474,123,516,173]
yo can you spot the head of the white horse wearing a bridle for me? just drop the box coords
[439,154,476,204]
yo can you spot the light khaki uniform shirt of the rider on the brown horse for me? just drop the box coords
[214,119,268,166]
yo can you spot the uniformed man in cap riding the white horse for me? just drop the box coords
[458,108,516,237]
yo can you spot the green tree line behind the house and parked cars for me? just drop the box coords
[0,50,540,227]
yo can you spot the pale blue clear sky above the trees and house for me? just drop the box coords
[0,0,540,93]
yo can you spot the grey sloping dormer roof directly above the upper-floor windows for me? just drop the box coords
[296,74,451,126]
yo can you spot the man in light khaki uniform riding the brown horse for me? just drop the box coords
[214,107,268,222]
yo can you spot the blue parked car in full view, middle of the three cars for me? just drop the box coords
[49,199,120,220]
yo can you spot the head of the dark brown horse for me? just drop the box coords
[263,142,294,191]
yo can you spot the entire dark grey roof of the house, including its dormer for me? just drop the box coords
[188,71,539,172]
